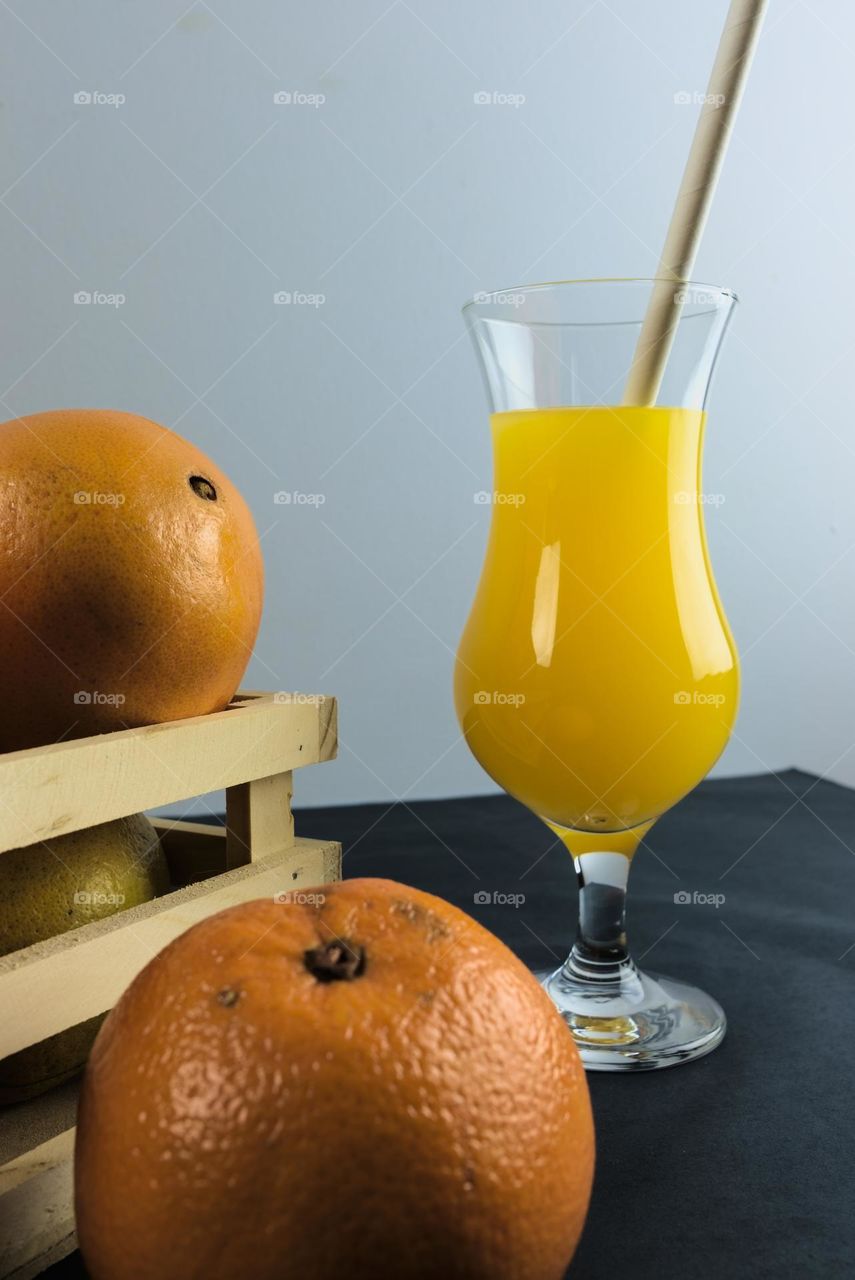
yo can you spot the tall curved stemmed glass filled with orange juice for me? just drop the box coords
[454,280,739,1070]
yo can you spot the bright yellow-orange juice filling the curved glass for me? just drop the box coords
[454,406,739,854]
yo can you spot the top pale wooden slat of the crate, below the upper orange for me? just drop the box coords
[0,694,337,854]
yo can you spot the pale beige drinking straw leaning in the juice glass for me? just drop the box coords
[623,0,767,404]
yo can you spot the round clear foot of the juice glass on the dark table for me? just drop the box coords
[535,961,727,1071]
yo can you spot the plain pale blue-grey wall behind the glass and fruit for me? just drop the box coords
[0,0,855,804]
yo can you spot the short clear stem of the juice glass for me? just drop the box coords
[563,854,637,996]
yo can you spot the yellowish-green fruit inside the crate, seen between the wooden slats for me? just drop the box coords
[0,813,169,1105]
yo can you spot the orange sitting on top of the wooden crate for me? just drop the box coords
[0,410,264,751]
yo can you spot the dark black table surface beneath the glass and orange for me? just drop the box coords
[47,771,855,1280]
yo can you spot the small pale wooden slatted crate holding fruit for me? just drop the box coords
[0,692,340,1280]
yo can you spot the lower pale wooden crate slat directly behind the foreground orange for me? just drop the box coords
[0,837,340,1054]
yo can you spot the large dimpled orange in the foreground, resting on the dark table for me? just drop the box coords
[76,879,594,1280]
